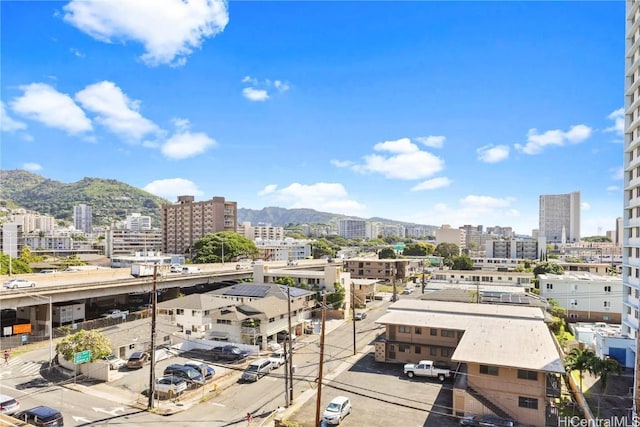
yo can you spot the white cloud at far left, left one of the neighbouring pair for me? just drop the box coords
[10,83,92,134]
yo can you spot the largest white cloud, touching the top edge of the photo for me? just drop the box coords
[64,0,229,66]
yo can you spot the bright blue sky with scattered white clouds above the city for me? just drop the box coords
[0,0,624,236]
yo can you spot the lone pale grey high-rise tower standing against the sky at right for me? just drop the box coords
[538,191,580,244]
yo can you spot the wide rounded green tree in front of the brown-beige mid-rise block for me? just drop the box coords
[189,231,258,264]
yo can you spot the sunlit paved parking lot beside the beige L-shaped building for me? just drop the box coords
[288,354,459,427]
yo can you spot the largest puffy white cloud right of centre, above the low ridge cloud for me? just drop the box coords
[352,138,444,180]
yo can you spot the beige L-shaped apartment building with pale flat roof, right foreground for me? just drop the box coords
[375,300,565,426]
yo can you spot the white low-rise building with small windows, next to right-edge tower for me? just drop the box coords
[538,273,622,323]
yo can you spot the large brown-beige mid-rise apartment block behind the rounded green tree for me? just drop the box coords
[162,196,238,254]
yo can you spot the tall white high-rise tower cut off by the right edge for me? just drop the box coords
[622,0,640,419]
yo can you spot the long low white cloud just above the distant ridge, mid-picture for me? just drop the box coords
[262,182,365,215]
